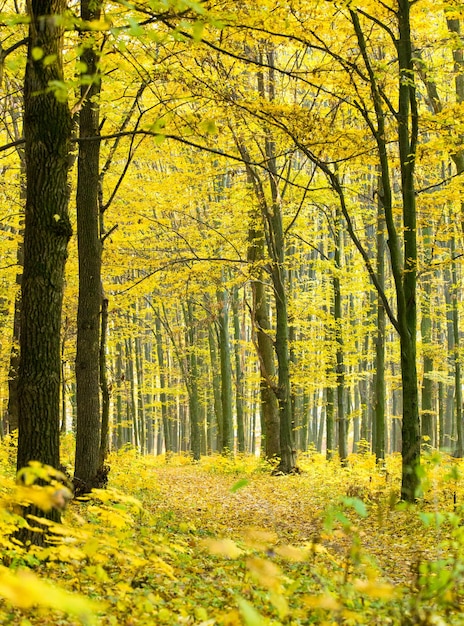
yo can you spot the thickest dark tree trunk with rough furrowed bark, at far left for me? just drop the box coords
[17,0,72,532]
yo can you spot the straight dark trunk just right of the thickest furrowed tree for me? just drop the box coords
[74,0,102,493]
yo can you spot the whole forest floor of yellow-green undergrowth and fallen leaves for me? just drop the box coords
[0,441,464,626]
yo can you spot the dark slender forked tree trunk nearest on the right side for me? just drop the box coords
[350,0,420,502]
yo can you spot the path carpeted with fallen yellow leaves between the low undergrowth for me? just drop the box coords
[118,456,452,584]
